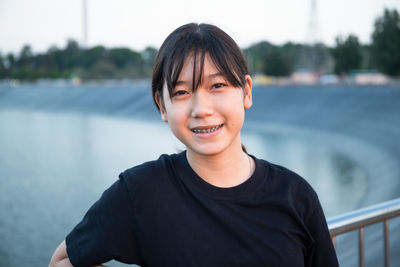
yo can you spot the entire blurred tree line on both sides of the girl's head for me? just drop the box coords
[0,9,400,80]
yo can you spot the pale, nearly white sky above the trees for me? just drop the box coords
[0,0,400,54]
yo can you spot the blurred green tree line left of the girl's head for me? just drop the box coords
[0,40,157,80]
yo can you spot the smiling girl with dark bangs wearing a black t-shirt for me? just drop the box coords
[50,23,338,267]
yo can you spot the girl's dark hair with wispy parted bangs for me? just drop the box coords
[151,23,249,109]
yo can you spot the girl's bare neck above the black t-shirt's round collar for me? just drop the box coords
[186,138,255,187]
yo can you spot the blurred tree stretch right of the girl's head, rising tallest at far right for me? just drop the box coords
[244,9,400,77]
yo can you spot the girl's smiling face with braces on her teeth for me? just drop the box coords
[157,54,252,159]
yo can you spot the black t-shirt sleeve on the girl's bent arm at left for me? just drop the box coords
[66,175,140,267]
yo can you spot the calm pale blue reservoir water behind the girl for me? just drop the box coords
[0,109,366,266]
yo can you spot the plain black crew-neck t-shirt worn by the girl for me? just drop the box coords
[66,152,338,267]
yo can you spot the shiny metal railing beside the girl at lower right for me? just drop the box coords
[328,198,400,267]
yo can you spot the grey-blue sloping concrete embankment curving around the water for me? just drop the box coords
[0,85,400,266]
